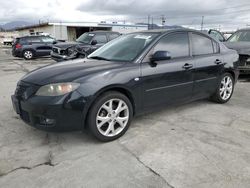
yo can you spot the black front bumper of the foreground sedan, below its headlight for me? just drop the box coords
[11,91,86,131]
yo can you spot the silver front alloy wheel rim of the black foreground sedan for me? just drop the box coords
[96,99,130,137]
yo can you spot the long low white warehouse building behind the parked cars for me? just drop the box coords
[16,22,148,41]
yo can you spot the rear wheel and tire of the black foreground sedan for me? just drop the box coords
[212,73,234,104]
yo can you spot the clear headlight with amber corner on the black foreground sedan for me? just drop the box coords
[36,83,80,96]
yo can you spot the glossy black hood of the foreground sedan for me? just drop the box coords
[22,59,125,85]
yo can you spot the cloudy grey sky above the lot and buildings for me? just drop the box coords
[0,0,250,30]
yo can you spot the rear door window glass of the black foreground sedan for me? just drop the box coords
[192,34,214,55]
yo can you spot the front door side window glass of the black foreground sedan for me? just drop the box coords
[154,33,189,58]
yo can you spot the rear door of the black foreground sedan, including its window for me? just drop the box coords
[190,32,224,98]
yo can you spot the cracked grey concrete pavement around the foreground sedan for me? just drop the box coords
[0,48,250,188]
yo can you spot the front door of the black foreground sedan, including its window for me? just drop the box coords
[141,32,194,109]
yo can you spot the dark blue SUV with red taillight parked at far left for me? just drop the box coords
[12,36,57,60]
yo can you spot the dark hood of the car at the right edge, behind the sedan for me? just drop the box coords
[224,42,250,55]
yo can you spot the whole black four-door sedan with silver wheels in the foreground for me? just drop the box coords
[12,29,239,141]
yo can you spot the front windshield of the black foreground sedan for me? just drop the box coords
[88,33,159,61]
